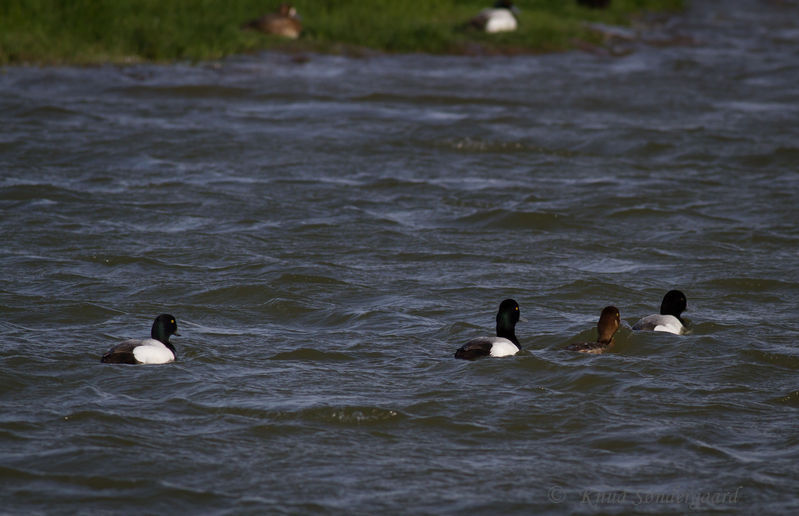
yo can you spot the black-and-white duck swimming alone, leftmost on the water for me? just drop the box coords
[100,314,180,364]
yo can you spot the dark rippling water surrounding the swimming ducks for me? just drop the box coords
[0,1,799,514]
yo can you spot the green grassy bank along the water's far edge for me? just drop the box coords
[0,0,684,64]
